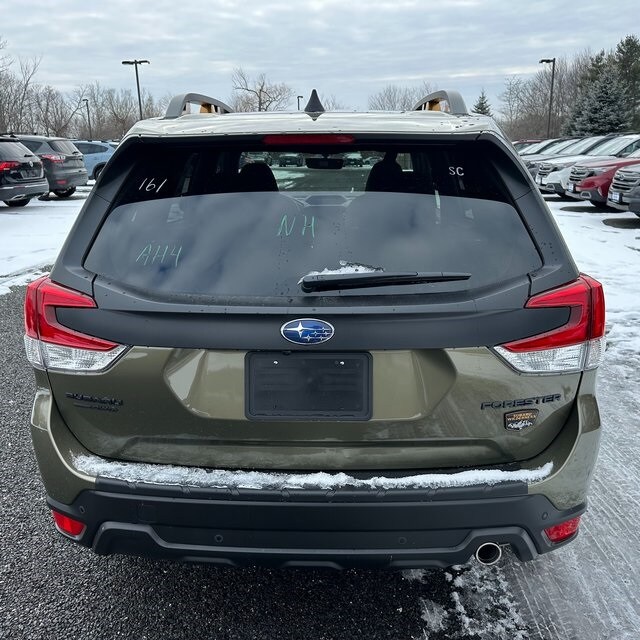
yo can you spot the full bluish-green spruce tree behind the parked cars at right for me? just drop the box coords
[564,66,631,136]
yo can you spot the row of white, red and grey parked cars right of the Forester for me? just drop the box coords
[515,133,640,216]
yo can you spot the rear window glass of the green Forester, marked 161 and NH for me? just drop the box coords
[85,143,541,304]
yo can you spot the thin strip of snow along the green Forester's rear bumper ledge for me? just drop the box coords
[73,455,553,490]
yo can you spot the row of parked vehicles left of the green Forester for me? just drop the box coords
[0,134,117,207]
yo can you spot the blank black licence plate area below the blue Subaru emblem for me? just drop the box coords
[245,351,372,421]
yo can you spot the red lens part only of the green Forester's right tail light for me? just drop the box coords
[502,274,605,352]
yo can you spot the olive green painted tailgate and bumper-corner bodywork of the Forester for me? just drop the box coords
[32,348,600,508]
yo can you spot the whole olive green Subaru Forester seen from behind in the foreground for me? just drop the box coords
[25,87,604,568]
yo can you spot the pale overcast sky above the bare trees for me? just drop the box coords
[0,0,640,111]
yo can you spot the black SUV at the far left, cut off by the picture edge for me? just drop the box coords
[0,136,49,207]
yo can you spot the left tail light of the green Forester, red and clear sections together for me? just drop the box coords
[24,276,126,372]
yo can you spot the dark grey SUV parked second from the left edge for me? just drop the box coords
[18,134,88,198]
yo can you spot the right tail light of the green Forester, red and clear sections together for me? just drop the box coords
[494,274,605,373]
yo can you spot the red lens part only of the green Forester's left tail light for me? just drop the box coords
[24,276,118,351]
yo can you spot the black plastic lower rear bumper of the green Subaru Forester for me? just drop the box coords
[48,478,585,569]
